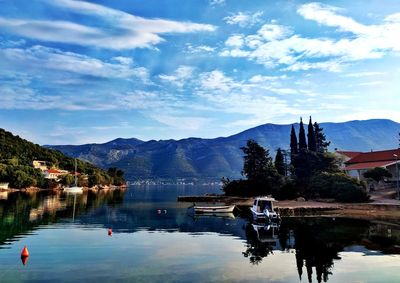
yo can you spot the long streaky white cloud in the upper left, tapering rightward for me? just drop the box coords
[0,0,215,50]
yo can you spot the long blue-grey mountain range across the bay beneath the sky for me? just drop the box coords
[47,119,400,179]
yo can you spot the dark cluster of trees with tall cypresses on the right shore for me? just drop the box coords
[222,117,368,202]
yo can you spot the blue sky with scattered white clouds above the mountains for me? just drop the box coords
[0,0,400,144]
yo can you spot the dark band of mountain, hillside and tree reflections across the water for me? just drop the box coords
[0,187,400,282]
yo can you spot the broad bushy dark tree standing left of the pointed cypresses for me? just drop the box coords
[240,140,276,181]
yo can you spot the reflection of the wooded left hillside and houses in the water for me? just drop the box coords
[0,190,125,247]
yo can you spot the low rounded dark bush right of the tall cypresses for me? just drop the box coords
[309,172,369,202]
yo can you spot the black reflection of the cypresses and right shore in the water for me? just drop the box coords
[243,218,400,282]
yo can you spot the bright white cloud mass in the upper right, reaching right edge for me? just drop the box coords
[220,3,400,72]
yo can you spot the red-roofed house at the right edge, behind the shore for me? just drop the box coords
[343,149,400,182]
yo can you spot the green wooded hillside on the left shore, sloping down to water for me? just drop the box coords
[0,129,125,189]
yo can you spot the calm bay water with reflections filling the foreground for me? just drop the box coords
[0,186,400,282]
